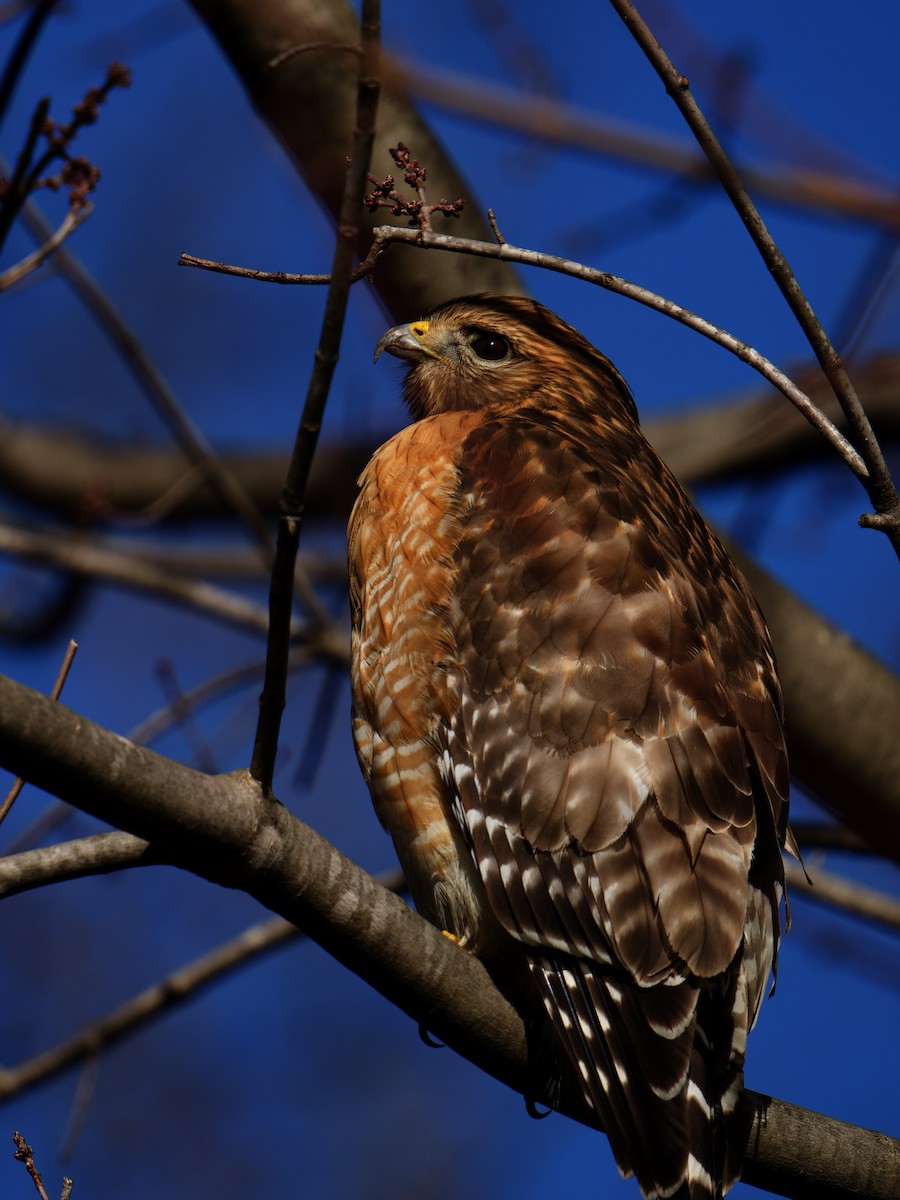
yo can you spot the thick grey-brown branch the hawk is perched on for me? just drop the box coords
[0,677,900,1200]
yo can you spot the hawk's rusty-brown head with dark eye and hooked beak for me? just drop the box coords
[376,295,637,424]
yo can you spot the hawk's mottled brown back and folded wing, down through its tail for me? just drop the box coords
[445,419,787,1194]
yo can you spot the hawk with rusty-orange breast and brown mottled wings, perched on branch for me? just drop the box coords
[349,295,788,1200]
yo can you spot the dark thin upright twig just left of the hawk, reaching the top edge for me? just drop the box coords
[250,0,380,792]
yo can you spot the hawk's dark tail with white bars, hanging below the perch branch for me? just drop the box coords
[529,955,743,1200]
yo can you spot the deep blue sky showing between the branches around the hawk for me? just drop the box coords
[0,0,900,1200]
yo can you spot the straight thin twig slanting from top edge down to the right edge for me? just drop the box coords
[610,0,900,557]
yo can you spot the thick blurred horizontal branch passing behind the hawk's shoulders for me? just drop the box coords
[7,350,900,520]
